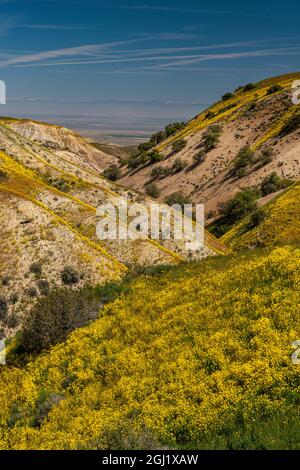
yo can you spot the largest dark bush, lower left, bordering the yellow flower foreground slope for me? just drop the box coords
[17,288,100,353]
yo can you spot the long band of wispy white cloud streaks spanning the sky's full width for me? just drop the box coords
[0,33,300,73]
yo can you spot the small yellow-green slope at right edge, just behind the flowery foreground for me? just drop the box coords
[221,183,300,251]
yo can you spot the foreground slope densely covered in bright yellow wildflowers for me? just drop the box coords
[0,247,300,449]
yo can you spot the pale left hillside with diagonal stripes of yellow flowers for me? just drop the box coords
[0,118,226,337]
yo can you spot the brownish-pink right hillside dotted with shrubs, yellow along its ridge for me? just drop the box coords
[120,73,300,219]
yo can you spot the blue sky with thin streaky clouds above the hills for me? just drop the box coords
[0,0,300,141]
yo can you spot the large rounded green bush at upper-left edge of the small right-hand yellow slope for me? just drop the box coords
[222,188,258,225]
